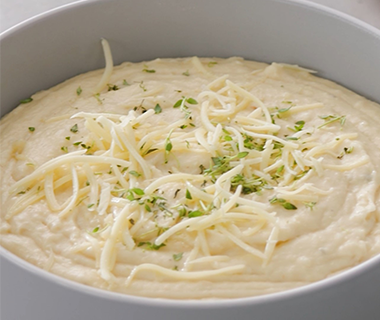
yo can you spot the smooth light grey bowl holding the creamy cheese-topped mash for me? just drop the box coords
[0,0,380,320]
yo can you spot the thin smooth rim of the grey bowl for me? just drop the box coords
[0,0,380,309]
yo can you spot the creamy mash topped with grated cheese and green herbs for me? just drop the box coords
[0,53,380,299]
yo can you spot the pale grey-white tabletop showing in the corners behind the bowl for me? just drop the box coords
[0,0,380,32]
